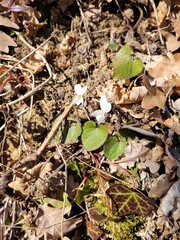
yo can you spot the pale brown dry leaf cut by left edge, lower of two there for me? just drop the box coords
[0,31,17,53]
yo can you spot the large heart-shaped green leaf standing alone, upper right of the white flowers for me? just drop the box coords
[113,44,143,79]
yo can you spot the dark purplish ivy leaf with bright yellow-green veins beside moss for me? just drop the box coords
[106,184,156,217]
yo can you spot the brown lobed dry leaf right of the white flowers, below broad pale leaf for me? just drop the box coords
[141,88,166,110]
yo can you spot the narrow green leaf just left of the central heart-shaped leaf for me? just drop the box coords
[65,121,82,144]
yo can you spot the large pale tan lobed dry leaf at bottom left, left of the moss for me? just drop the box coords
[36,204,82,239]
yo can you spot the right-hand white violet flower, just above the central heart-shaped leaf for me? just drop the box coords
[91,96,111,124]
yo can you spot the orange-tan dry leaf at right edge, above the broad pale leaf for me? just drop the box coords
[162,31,180,52]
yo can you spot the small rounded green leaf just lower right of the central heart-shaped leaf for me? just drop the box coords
[103,137,126,161]
